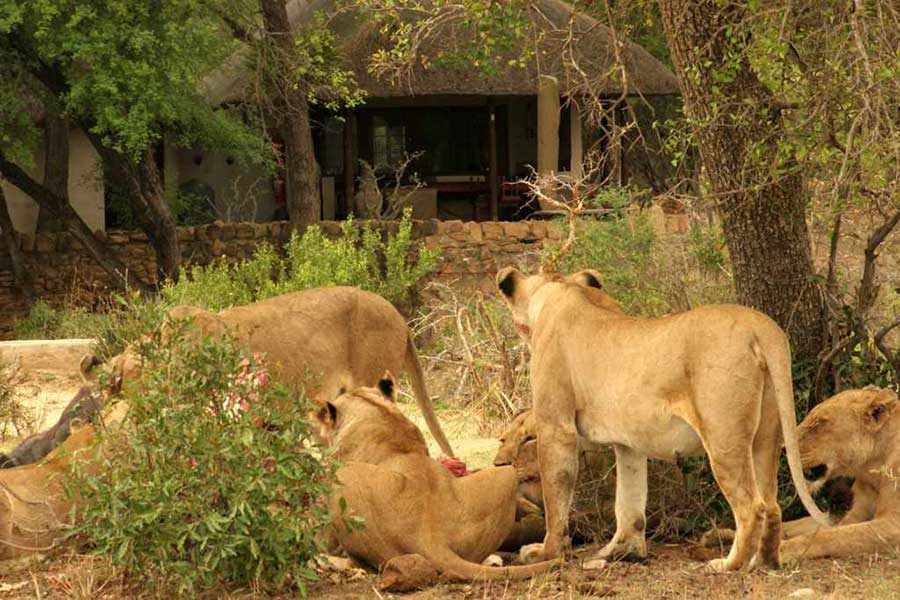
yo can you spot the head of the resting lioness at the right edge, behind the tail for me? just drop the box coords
[797,386,898,491]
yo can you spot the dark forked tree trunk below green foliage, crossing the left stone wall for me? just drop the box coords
[100,149,181,283]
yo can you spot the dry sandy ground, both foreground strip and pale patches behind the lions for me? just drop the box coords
[0,344,900,600]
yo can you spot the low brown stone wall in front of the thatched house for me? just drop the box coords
[0,220,563,338]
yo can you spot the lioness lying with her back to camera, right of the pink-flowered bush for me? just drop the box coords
[311,377,551,580]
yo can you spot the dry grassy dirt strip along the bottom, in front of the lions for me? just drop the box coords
[0,544,900,600]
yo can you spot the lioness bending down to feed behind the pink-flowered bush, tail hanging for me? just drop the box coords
[82,287,453,456]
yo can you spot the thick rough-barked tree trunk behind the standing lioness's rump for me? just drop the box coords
[659,0,825,359]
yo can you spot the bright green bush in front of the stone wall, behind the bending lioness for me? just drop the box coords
[163,210,439,310]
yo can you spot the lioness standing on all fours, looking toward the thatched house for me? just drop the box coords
[497,268,827,571]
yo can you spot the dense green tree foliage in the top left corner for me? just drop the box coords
[0,0,261,164]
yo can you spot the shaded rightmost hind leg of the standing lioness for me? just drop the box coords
[753,400,781,569]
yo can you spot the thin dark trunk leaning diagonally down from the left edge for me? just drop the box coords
[0,154,151,293]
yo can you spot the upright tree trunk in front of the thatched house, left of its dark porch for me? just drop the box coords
[260,0,322,228]
